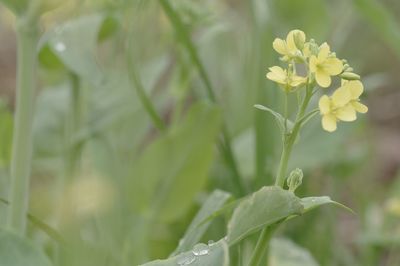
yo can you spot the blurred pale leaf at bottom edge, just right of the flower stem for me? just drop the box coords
[269,238,319,266]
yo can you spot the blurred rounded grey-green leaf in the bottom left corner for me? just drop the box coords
[0,230,51,266]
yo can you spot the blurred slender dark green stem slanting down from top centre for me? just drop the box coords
[159,0,246,196]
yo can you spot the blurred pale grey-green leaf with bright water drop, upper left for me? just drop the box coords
[39,15,106,85]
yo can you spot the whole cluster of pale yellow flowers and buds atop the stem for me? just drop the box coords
[266,30,368,132]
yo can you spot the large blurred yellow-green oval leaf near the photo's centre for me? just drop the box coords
[126,104,220,221]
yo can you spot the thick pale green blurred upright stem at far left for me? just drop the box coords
[8,18,39,235]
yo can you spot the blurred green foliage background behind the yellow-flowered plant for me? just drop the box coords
[0,0,400,266]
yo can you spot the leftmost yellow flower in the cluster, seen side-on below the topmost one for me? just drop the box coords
[267,66,307,91]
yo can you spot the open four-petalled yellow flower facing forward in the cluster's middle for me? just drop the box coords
[310,43,343,88]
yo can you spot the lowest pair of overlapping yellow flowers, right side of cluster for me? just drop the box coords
[319,80,368,132]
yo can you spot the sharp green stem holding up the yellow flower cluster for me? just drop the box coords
[249,83,312,266]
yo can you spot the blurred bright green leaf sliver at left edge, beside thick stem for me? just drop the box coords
[0,102,13,166]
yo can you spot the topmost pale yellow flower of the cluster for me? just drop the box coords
[272,30,306,61]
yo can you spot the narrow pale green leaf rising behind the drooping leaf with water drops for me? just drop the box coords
[173,190,231,255]
